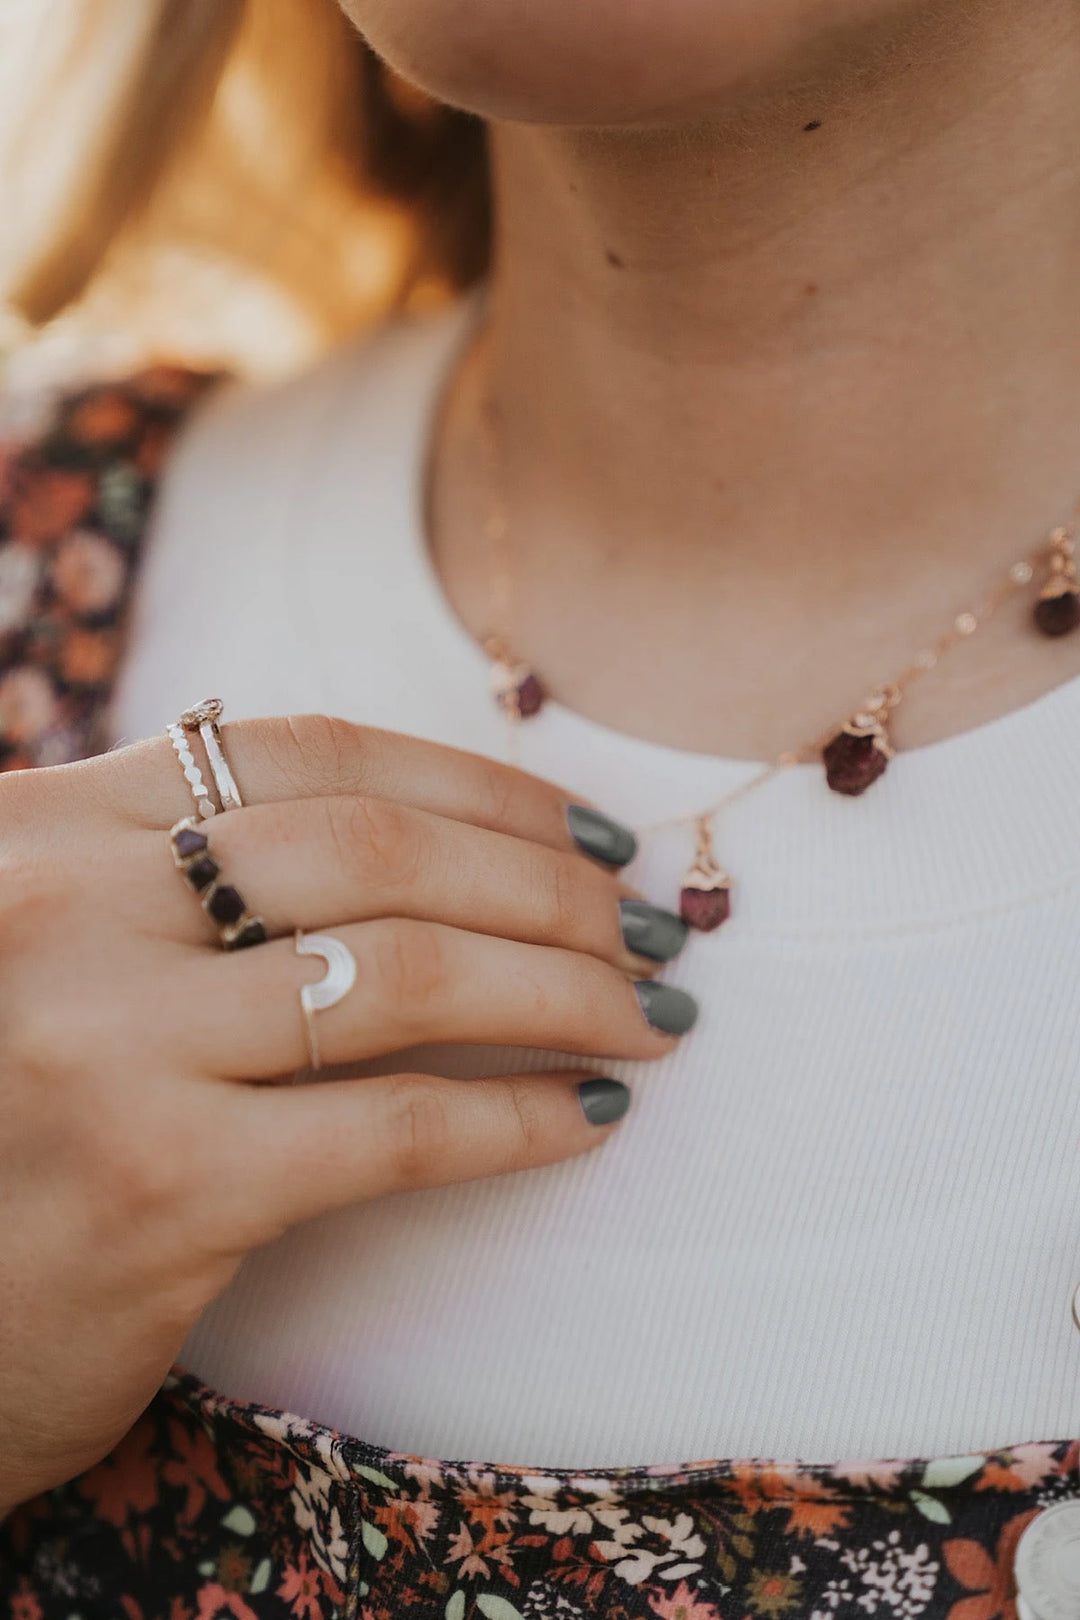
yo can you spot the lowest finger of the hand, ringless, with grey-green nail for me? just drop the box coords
[215,1071,630,1243]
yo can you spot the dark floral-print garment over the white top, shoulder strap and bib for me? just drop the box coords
[0,366,1080,1620]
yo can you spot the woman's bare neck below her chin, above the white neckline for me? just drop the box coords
[436,0,1080,753]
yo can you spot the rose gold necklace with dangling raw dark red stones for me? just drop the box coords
[469,354,1080,933]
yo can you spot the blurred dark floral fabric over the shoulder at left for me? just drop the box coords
[0,366,217,771]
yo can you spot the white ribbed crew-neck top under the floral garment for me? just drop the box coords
[117,301,1080,1468]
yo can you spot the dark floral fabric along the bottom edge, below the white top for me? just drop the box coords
[0,1367,1080,1620]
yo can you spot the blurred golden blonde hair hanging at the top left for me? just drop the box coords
[8,0,489,358]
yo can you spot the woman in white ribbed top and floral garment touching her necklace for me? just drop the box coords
[0,0,1080,1620]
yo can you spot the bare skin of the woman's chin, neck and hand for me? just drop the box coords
[8,0,1080,1507]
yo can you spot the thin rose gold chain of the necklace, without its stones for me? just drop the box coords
[479,332,1072,833]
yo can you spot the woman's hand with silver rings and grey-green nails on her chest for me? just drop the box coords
[0,718,693,1513]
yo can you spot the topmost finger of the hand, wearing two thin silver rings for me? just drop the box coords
[93,714,636,867]
